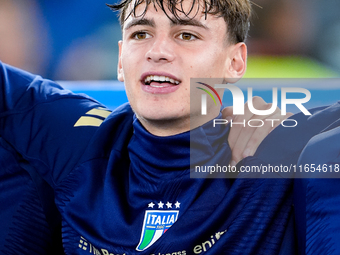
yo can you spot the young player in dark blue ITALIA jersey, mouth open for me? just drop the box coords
[0,0,308,255]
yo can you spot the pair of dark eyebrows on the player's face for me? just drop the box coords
[125,18,208,30]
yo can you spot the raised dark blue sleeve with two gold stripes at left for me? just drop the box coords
[0,62,110,186]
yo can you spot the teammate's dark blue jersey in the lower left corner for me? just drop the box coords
[0,138,63,255]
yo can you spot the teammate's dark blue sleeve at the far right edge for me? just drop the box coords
[295,124,340,254]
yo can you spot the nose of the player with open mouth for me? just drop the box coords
[146,36,175,63]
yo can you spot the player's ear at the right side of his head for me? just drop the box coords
[225,42,247,80]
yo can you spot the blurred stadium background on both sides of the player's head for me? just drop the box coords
[0,0,340,81]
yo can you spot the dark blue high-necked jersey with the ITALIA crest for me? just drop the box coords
[0,64,340,255]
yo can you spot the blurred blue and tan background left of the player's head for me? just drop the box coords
[0,0,121,80]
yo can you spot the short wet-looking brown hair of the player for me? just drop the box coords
[108,0,252,43]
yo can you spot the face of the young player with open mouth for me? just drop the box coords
[118,2,246,136]
